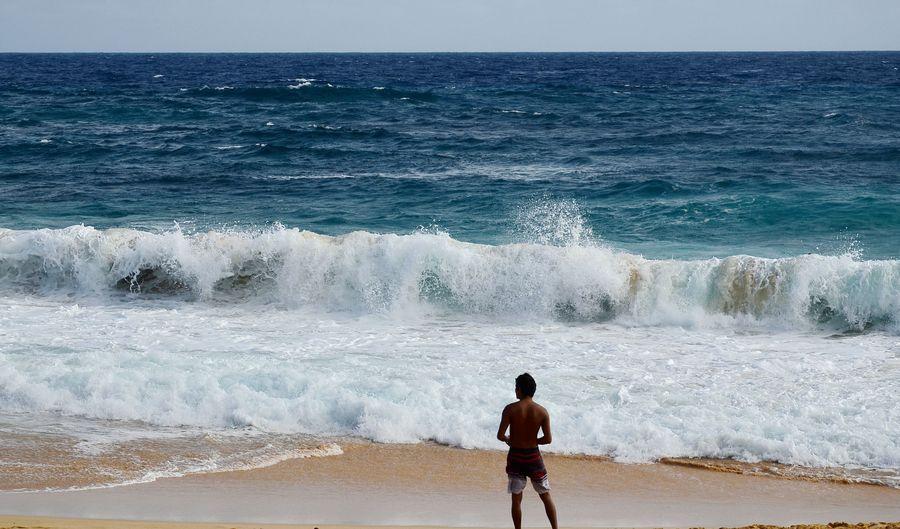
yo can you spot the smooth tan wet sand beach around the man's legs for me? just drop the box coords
[0,442,900,528]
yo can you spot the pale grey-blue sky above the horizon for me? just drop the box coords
[0,0,900,52]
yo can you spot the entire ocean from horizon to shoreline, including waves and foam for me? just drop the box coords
[0,52,900,490]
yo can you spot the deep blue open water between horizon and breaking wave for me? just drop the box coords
[0,52,900,259]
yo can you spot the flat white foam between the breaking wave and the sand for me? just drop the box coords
[0,298,900,480]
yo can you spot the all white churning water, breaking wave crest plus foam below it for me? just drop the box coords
[0,222,900,484]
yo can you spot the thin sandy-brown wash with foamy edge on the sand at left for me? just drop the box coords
[0,413,342,492]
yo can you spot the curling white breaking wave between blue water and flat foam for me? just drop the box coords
[0,226,900,331]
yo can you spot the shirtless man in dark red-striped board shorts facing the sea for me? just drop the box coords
[497,373,557,529]
